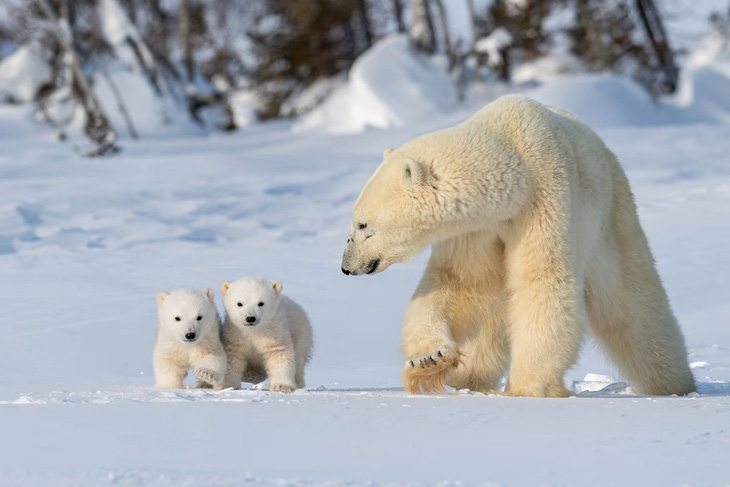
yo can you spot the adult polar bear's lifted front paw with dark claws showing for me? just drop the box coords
[403,346,461,394]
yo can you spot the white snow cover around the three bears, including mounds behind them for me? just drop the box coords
[0,2,730,487]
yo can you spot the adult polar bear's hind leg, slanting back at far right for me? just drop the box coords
[586,168,695,395]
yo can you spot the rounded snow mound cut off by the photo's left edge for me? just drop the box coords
[0,44,53,103]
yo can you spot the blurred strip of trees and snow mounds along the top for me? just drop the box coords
[0,0,730,155]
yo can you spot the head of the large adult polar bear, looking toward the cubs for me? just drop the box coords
[342,149,432,276]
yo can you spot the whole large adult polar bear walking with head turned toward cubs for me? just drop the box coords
[342,96,695,397]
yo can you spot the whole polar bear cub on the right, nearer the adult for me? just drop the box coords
[221,277,312,392]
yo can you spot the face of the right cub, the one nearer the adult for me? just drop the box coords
[221,277,282,327]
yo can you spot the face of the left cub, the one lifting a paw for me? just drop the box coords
[157,288,218,345]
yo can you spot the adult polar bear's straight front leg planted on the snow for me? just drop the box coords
[505,202,587,397]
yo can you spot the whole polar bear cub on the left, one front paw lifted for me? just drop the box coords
[153,288,227,389]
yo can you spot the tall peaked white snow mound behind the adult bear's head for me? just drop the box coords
[293,36,458,134]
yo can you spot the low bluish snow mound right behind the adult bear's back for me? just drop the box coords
[527,74,689,127]
